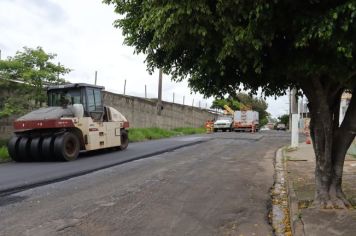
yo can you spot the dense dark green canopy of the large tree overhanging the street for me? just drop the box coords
[104,0,356,96]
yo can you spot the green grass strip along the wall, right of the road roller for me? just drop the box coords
[129,128,205,142]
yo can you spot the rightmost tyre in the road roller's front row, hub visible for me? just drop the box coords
[54,132,80,161]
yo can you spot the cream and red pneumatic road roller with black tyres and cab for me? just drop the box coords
[8,83,129,162]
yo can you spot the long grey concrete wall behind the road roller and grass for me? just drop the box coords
[0,92,214,139]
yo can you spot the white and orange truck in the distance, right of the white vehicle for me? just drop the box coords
[232,110,259,132]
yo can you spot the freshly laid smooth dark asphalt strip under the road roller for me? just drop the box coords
[0,135,211,196]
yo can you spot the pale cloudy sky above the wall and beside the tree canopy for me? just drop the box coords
[0,0,289,117]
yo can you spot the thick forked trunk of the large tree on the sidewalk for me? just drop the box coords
[303,79,356,208]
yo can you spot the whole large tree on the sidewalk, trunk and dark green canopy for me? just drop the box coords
[104,0,356,208]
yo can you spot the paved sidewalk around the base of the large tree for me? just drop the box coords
[284,143,356,236]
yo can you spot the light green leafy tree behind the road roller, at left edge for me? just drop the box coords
[0,47,70,117]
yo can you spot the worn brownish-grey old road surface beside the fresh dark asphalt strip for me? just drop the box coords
[0,131,289,236]
